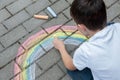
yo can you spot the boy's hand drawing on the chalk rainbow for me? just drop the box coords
[53,37,65,50]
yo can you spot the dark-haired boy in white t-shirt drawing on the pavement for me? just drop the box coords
[53,0,120,80]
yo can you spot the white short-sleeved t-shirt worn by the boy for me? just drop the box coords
[73,23,120,80]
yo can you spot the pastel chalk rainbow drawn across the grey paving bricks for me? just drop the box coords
[14,25,87,80]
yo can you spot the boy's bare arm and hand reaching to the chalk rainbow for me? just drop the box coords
[53,38,76,70]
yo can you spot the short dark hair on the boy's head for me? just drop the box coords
[70,0,107,30]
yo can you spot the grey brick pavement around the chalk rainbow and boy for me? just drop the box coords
[0,0,120,80]
